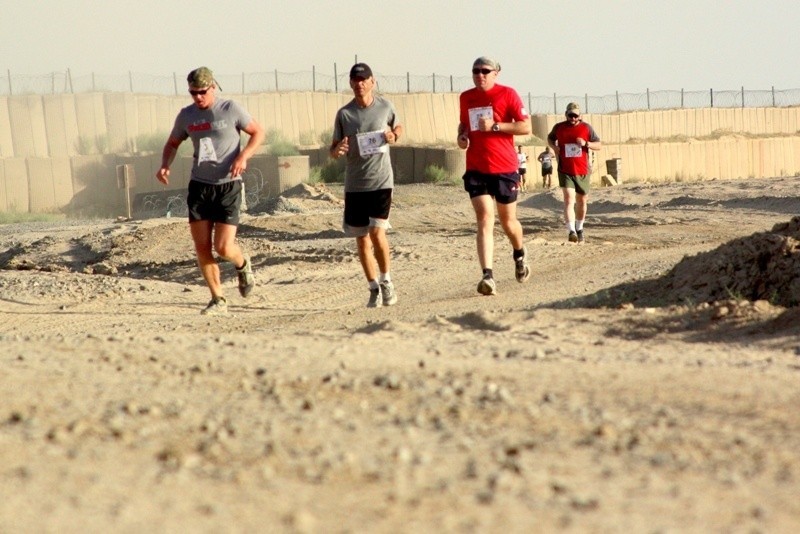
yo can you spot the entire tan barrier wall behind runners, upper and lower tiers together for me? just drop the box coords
[0,92,800,215]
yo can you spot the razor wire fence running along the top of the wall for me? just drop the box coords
[0,68,800,115]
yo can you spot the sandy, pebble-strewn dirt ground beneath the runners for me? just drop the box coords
[0,178,800,533]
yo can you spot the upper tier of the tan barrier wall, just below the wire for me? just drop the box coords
[0,92,800,157]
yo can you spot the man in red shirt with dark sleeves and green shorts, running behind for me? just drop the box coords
[547,102,603,243]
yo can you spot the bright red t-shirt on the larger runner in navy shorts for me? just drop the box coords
[459,84,530,174]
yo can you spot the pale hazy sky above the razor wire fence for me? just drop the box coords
[0,0,800,95]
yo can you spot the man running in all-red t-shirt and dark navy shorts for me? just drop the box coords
[457,57,531,295]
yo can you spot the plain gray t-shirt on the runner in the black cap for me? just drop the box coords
[333,96,400,193]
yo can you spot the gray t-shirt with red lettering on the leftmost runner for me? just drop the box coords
[170,99,252,184]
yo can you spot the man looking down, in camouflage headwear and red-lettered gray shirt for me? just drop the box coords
[156,67,264,315]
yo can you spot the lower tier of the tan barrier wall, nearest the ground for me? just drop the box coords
[0,136,800,215]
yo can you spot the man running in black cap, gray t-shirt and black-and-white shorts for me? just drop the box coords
[330,63,403,308]
